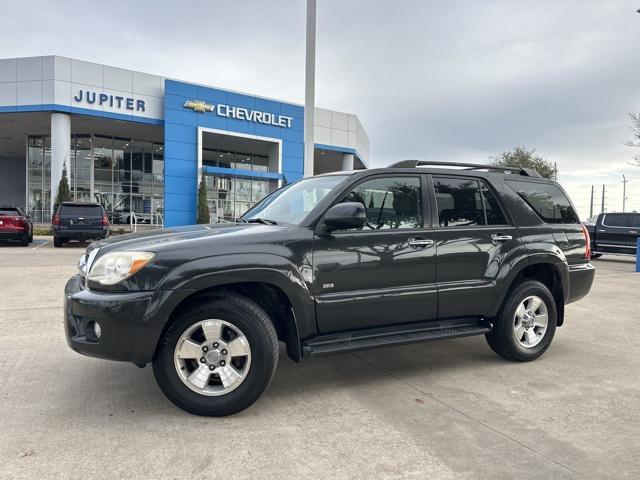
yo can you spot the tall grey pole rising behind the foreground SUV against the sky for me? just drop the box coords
[304,0,316,177]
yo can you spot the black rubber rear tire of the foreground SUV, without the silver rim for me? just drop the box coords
[485,280,558,362]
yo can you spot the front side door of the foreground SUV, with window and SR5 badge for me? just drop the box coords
[313,173,437,333]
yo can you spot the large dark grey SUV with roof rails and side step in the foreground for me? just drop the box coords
[65,161,594,416]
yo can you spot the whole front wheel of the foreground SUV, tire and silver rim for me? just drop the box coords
[153,293,278,417]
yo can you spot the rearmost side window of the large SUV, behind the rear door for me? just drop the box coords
[505,180,580,223]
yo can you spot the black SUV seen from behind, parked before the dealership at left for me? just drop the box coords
[51,202,109,247]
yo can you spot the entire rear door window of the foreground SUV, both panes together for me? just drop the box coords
[433,177,507,227]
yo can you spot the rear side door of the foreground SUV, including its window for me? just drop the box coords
[431,175,518,319]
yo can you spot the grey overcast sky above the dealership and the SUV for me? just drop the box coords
[0,0,640,218]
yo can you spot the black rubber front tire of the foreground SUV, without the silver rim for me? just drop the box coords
[153,293,278,417]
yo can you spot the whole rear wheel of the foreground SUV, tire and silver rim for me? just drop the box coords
[485,280,558,362]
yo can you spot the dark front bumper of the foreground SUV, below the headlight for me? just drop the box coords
[64,275,191,365]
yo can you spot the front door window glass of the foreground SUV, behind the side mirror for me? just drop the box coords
[343,177,422,230]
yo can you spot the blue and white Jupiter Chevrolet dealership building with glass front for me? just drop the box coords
[0,56,369,226]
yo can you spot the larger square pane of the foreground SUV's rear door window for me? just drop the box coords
[433,177,485,227]
